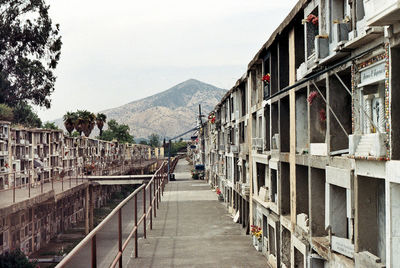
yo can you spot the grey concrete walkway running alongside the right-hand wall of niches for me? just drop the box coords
[127,160,269,267]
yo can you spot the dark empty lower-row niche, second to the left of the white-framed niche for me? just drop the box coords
[296,165,308,215]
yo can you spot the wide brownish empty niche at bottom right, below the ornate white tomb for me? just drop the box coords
[358,176,386,263]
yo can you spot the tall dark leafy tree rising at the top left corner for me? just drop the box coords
[0,0,62,108]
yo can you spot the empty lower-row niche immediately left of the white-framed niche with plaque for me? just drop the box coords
[310,168,326,236]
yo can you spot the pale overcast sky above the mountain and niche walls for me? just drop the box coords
[36,0,296,121]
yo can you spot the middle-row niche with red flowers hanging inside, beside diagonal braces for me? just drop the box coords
[308,80,326,143]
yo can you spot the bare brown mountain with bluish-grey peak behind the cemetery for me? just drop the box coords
[56,79,226,138]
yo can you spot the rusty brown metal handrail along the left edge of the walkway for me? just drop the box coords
[56,161,168,267]
